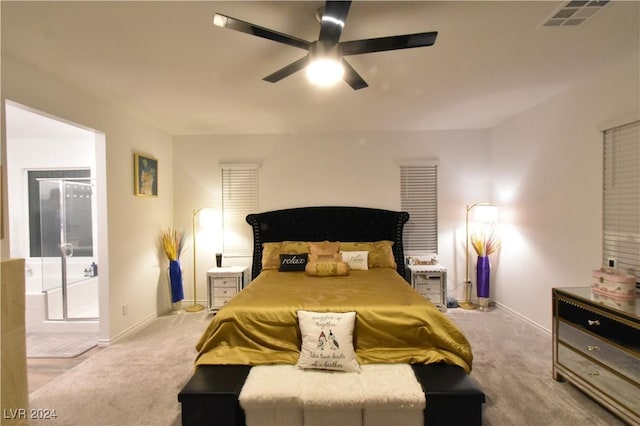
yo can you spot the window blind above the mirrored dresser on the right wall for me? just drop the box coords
[602,121,640,282]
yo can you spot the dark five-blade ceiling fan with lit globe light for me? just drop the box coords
[213,1,438,90]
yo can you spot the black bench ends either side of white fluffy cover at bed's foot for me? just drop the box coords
[178,364,485,426]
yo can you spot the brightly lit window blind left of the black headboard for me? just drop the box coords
[221,164,259,256]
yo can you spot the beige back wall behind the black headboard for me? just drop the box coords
[174,130,491,300]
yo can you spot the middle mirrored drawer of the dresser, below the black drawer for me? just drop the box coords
[558,320,640,384]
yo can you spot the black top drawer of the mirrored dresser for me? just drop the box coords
[558,300,640,355]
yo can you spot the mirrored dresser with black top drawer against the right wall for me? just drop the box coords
[552,287,640,424]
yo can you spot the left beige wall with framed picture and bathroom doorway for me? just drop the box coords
[2,57,173,341]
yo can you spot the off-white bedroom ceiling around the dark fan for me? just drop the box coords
[1,0,640,135]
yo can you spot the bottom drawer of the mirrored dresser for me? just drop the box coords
[558,343,640,416]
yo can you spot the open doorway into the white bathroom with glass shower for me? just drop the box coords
[5,101,107,341]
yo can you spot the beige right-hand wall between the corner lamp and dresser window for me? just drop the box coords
[491,55,640,329]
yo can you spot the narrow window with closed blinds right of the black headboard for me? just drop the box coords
[400,162,438,253]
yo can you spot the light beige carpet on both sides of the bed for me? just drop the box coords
[29,308,624,426]
